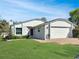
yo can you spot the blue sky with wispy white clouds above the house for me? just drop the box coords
[0,0,79,21]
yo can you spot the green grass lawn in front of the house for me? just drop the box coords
[0,39,79,59]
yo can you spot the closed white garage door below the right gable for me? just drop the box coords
[50,28,70,39]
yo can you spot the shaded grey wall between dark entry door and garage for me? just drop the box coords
[33,26,45,39]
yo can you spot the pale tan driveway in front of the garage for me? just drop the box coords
[36,38,79,45]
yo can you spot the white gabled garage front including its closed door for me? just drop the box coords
[50,21,72,39]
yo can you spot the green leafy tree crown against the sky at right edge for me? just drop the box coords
[69,8,79,25]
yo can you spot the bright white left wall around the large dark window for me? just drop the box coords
[11,20,44,36]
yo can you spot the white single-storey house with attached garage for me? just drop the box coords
[11,18,75,40]
